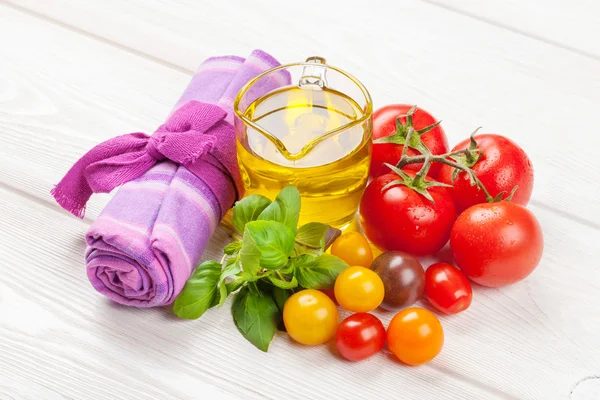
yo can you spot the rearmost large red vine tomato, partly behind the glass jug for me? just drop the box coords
[370,104,448,178]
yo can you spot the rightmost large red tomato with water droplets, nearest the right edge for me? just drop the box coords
[450,201,544,287]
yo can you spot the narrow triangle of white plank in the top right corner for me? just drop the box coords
[423,0,600,60]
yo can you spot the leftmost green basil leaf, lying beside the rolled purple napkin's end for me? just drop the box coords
[173,261,221,319]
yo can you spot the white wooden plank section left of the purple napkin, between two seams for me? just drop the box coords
[0,5,189,218]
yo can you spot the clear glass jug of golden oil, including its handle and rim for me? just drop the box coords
[234,57,373,229]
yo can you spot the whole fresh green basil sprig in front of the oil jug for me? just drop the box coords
[173,186,348,351]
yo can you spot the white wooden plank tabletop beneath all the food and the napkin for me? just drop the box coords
[0,0,600,400]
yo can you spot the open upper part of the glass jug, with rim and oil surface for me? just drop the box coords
[234,56,372,162]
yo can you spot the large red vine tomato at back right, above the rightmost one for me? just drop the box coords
[437,133,533,214]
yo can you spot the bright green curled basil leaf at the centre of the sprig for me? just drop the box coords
[242,221,294,269]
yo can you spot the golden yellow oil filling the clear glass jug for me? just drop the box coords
[237,86,371,228]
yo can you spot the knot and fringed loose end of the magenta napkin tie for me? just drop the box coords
[51,100,233,218]
